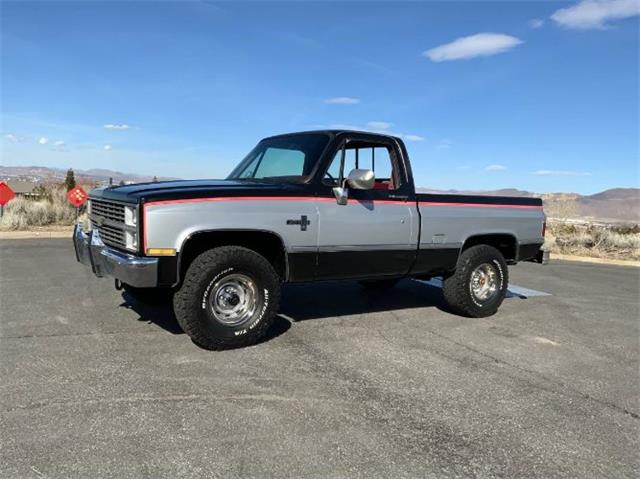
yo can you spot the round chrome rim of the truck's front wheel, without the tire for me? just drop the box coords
[209,273,258,327]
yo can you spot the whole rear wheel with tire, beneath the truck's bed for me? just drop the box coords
[442,245,509,318]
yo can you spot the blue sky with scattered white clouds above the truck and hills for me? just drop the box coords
[0,0,640,194]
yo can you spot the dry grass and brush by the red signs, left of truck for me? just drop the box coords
[0,188,85,230]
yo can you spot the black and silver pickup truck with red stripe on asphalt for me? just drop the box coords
[74,130,545,350]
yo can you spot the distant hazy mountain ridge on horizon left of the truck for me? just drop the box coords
[0,165,173,184]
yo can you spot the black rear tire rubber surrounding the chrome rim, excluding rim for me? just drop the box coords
[442,245,509,318]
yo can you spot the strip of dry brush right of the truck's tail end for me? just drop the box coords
[545,222,640,260]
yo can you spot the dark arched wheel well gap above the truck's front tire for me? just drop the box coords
[179,230,287,281]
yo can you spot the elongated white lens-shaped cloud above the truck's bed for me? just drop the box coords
[423,33,522,62]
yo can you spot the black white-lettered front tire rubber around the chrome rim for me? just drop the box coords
[173,246,280,350]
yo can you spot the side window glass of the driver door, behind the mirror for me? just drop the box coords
[322,144,398,190]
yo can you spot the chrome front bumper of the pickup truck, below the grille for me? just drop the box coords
[73,225,158,287]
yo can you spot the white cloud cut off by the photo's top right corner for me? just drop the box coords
[551,0,640,29]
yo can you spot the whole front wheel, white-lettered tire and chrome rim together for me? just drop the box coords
[173,246,280,350]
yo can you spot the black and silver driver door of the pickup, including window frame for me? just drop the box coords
[317,134,419,279]
